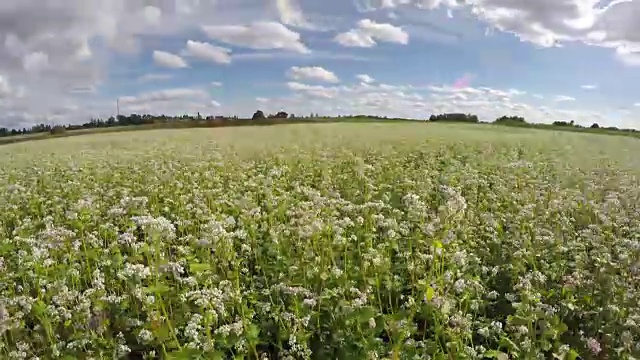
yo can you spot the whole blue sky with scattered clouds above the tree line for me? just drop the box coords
[0,0,640,128]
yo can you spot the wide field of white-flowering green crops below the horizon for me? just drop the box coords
[0,124,640,359]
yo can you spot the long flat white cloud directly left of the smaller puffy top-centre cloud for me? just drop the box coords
[202,22,309,53]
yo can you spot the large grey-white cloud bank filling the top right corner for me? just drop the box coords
[351,0,640,66]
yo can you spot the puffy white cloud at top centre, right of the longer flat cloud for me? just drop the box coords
[334,19,409,47]
